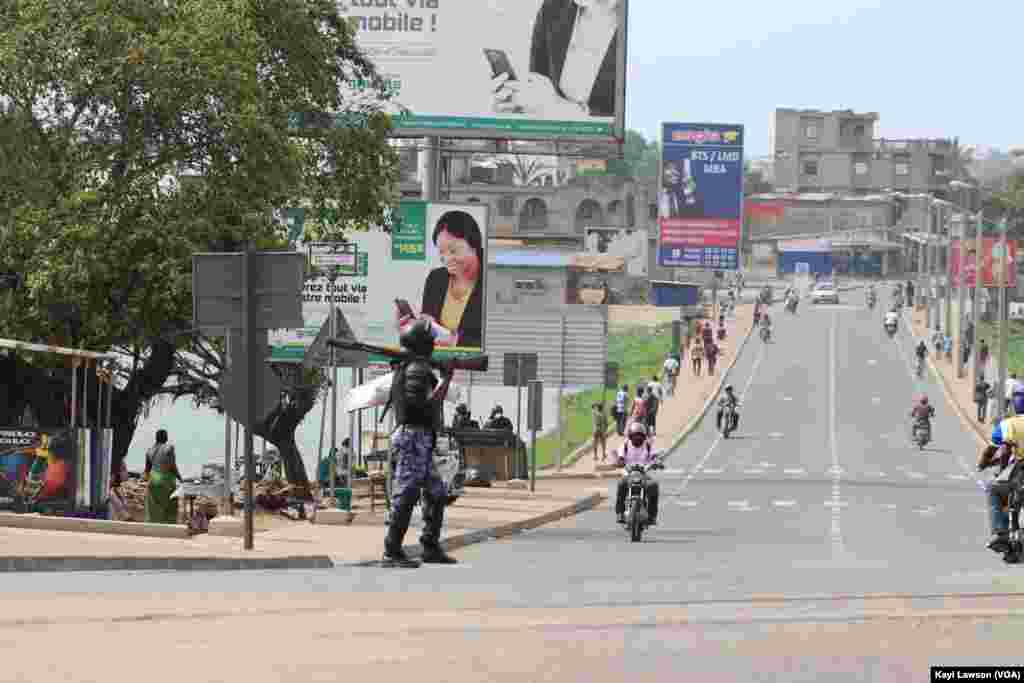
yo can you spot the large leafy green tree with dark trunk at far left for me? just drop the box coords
[0,0,397,491]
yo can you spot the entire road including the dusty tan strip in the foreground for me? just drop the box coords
[0,292,1024,683]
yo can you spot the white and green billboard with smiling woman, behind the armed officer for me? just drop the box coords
[269,201,488,361]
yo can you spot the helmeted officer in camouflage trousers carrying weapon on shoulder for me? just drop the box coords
[383,321,457,567]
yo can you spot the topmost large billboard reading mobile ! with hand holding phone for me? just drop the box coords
[338,0,627,140]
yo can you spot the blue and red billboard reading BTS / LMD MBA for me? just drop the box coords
[657,123,743,270]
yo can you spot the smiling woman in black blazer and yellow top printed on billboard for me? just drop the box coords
[398,211,484,348]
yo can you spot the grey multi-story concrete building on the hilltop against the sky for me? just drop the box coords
[772,109,959,199]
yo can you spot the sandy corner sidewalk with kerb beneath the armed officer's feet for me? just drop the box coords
[0,481,604,571]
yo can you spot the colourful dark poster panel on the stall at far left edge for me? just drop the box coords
[0,427,78,512]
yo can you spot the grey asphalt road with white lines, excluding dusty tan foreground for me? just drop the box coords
[0,292,1019,607]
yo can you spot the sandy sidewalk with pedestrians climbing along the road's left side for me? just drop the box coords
[537,303,754,480]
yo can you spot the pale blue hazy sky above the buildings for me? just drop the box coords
[626,0,1024,156]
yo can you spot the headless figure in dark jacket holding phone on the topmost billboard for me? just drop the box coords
[487,0,623,119]
